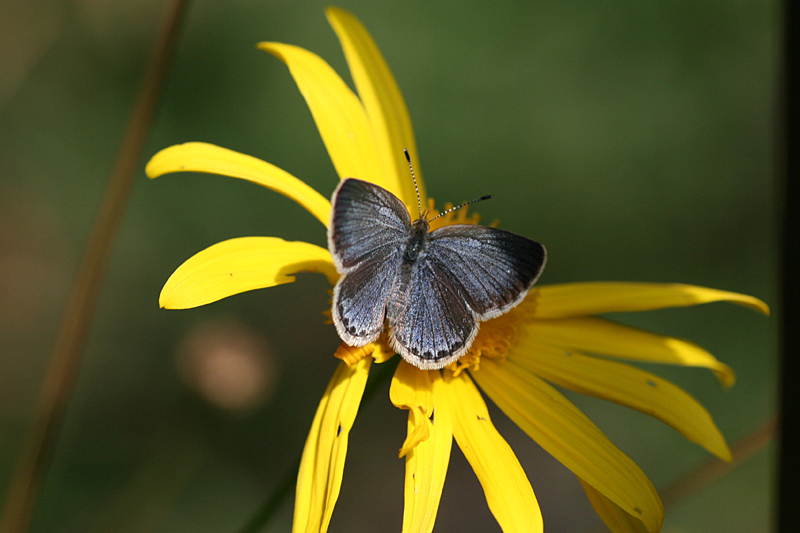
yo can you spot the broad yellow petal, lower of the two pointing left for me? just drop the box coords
[159,237,338,309]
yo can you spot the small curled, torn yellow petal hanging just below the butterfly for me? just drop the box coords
[389,361,433,457]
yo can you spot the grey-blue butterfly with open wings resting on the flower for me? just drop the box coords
[328,169,547,370]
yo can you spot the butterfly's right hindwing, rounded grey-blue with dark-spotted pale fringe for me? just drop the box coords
[386,257,478,370]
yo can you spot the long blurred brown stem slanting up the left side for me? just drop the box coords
[0,0,188,533]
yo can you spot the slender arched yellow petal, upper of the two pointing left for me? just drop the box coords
[145,143,331,226]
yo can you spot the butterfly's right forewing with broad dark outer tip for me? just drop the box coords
[426,224,547,320]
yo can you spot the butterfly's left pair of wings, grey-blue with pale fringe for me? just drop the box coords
[328,178,411,346]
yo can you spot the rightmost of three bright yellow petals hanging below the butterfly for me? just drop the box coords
[442,371,543,533]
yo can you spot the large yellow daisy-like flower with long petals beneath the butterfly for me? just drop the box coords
[147,8,768,533]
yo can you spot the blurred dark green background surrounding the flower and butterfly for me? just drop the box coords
[0,0,781,533]
